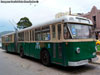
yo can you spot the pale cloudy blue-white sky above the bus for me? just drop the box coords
[0,0,100,32]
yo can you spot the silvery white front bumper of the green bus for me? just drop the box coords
[68,57,98,66]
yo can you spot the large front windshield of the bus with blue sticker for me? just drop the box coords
[68,24,94,39]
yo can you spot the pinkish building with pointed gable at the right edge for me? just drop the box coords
[81,6,100,39]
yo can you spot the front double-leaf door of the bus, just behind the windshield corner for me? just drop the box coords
[52,24,63,64]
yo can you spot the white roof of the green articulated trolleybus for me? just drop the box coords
[3,15,93,36]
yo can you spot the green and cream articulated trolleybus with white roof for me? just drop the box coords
[2,15,97,66]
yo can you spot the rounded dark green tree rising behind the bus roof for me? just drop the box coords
[17,17,32,29]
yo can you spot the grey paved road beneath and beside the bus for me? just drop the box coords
[0,49,100,75]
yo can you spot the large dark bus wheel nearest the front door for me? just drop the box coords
[41,50,50,66]
